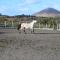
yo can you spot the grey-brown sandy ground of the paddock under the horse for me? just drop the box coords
[0,29,60,60]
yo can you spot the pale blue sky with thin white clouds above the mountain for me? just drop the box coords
[0,0,60,16]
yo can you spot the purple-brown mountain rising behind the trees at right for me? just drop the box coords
[33,8,60,17]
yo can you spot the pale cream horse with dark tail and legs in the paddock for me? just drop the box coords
[18,20,37,33]
